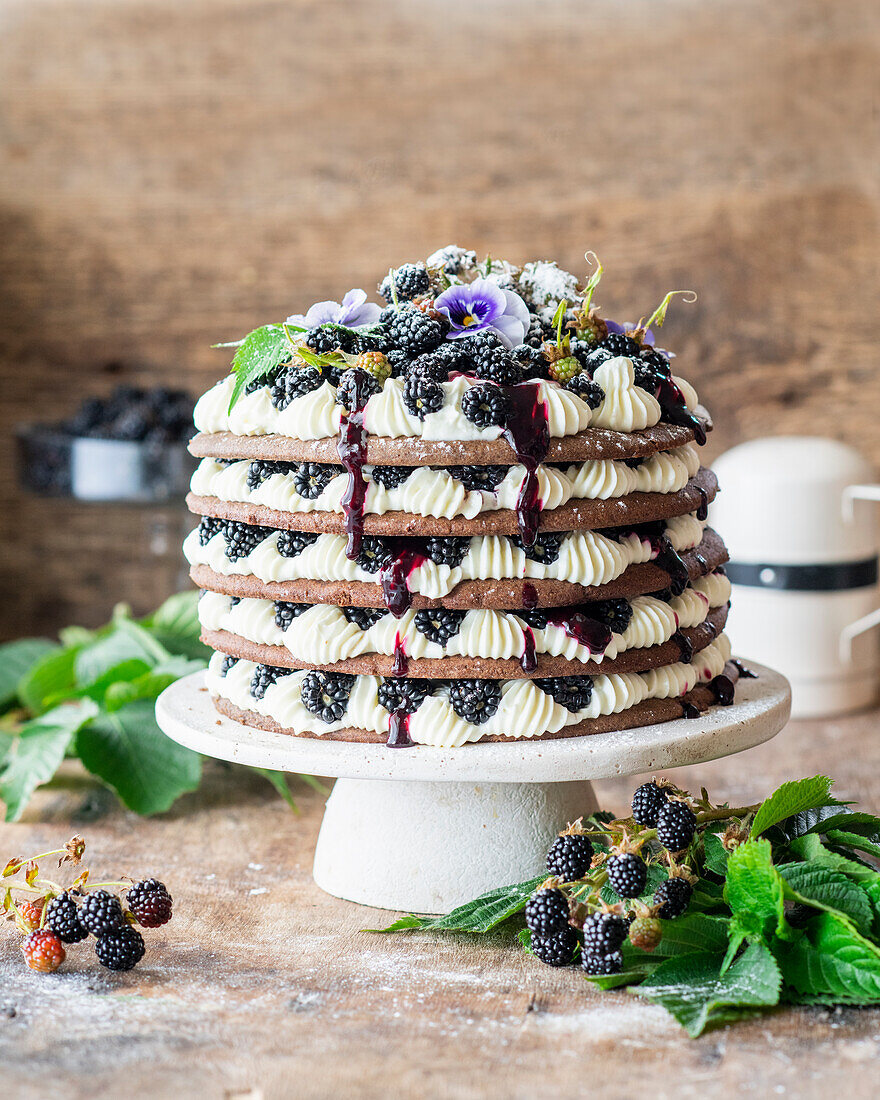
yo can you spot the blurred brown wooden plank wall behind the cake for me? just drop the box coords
[0,0,880,635]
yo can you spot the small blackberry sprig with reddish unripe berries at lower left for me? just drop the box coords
[2,836,173,974]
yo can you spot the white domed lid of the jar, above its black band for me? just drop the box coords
[710,436,878,564]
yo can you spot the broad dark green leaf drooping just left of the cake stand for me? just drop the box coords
[76,699,201,814]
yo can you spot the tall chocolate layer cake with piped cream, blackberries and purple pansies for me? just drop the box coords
[185,246,738,748]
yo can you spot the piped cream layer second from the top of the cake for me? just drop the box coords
[190,443,700,519]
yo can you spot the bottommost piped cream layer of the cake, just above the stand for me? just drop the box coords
[207,635,730,748]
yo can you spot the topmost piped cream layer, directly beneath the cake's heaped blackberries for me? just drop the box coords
[194,356,696,440]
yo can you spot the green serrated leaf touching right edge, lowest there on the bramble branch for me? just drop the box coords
[774,913,880,1004]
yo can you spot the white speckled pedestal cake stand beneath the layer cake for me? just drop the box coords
[156,661,791,913]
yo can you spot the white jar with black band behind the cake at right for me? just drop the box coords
[710,436,880,717]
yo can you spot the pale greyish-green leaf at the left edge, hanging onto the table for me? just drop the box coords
[0,700,98,822]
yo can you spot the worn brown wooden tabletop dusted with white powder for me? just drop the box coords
[0,712,880,1100]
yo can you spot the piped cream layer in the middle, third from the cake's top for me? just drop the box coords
[184,514,705,598]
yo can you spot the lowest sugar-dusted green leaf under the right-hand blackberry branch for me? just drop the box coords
[634,944,781,1038]
